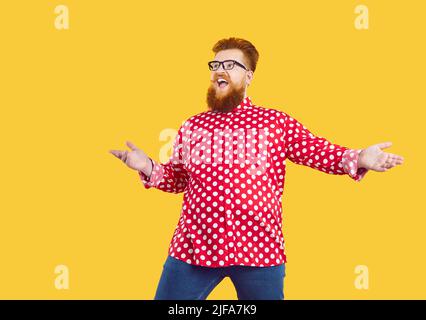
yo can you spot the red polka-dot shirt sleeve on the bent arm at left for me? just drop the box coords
[138,122,189,193]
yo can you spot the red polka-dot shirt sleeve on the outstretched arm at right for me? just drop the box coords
[280,113,368,182]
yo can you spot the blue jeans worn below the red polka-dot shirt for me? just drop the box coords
[154,255,285,300]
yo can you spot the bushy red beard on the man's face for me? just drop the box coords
[207,81,245,112]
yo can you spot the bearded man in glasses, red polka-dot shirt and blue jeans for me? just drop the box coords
[110,38,403,300]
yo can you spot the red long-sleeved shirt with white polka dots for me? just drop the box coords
[138,97,365,267]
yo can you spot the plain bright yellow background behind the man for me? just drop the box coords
[0,0,426,299]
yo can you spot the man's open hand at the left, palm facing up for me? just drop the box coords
[109,141,152,177]
